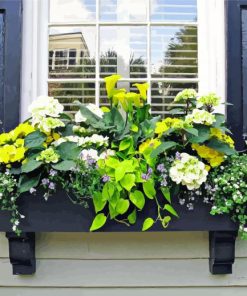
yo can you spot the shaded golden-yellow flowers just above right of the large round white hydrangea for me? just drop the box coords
[192,144,224,167]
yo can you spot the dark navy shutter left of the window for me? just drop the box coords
[0,0,22,131]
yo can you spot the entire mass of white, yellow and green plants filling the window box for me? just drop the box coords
[0,75,243,233]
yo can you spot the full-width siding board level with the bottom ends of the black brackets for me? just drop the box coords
[0,258,247,288]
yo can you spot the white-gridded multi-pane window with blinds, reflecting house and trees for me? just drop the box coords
[48,0,198,115]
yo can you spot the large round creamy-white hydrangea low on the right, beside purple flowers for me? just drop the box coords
[169,153,208,190]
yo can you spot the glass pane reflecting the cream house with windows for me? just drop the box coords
[49,27,96,78]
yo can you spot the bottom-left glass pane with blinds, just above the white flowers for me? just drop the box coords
[49,82,95,112]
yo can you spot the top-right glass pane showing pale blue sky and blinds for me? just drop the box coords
[151,0,197,22]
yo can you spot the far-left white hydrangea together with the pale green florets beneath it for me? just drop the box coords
[28,96,64,133]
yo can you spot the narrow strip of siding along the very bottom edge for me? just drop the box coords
[0,288,246,296]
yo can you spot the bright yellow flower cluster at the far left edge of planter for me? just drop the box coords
[0,123,34,164]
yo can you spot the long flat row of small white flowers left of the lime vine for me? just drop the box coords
[52,134,109,147]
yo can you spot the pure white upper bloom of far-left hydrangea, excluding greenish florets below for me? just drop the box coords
[28,96,64,125]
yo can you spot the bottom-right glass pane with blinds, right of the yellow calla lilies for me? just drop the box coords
[151,81,198,116]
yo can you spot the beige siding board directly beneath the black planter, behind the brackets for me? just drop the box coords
[0,232,247,259]
